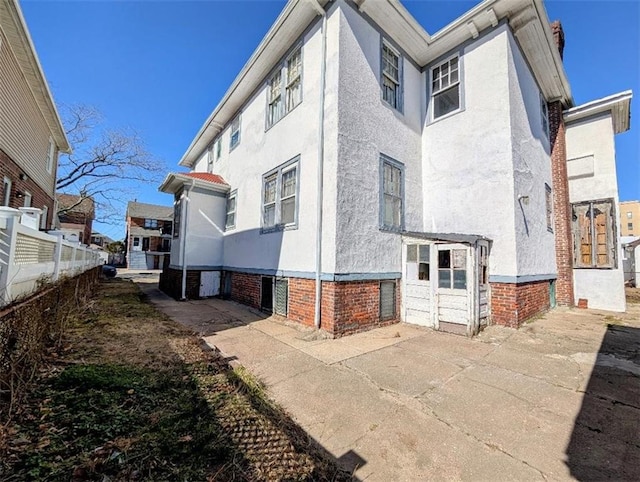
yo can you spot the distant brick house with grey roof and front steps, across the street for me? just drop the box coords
[125,201,173,269]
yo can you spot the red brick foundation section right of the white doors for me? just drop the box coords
[491,280,550,328]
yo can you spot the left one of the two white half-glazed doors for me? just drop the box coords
[402,243,433,326]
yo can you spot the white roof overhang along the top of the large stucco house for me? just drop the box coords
[179,0,573,168]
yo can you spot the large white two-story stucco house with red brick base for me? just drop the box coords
[160,0,631,336]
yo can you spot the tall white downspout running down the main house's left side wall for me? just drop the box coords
[310,0,327,329]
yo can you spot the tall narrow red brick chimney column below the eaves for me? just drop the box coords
[549,101,574,306]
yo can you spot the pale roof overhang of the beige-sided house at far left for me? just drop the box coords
[0,0,71,152]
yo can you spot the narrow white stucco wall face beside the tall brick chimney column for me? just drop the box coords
[508,31,557,276]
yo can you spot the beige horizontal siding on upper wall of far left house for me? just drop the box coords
[0,30,57,197]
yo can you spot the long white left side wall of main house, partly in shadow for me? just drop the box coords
[189,6,339,273]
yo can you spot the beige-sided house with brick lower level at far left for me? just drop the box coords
[0,0,70,229]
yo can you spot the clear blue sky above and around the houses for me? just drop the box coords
[21,0,640,239]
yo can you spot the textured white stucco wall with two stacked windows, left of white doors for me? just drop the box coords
[336,2,424,273]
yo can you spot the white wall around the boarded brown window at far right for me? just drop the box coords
[566,114,626,311]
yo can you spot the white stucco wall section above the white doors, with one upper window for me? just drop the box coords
[422,25,518,276]
